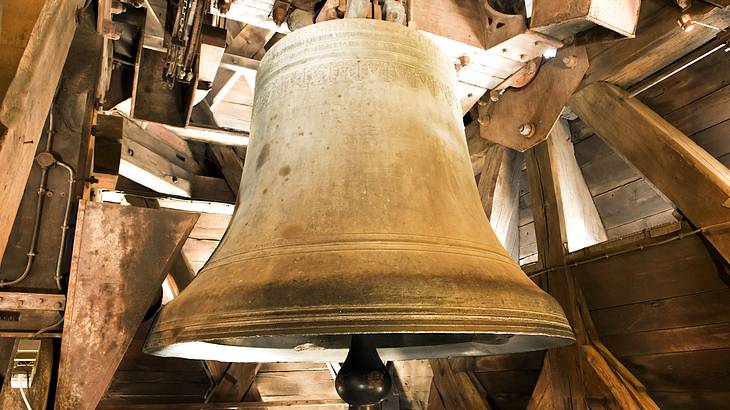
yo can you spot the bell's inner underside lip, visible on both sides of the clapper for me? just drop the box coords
[143,332,575,363]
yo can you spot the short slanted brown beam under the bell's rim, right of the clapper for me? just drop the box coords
[429,359,490,410]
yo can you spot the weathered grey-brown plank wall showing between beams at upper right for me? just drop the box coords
[520,32,730,264]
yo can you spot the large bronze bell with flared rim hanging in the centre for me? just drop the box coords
[145,19,574,362]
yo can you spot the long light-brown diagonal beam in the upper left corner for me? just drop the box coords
[0,0,83,262]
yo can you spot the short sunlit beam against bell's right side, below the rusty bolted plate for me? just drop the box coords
[478,144,522,261]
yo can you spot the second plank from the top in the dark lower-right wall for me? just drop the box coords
[591,289,730,336]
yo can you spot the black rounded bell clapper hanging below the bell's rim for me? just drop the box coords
[335,335,392,409]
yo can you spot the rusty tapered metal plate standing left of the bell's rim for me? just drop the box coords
[56,202,198,410]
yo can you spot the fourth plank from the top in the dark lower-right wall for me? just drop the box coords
[621,348,730,392]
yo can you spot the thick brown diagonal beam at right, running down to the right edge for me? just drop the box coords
[571,82,730,261]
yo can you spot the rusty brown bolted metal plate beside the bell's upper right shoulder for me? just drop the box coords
[479,47,588,151]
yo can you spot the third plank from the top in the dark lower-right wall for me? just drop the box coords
[603,318,730,357]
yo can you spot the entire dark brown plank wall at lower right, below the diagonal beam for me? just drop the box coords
[576,236,730,409]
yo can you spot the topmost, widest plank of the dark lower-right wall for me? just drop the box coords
[574,236,727,309]
